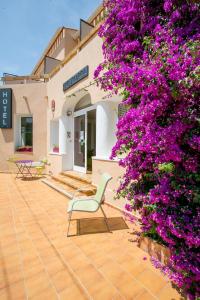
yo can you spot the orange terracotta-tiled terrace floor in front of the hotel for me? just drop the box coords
[0,174,180,300]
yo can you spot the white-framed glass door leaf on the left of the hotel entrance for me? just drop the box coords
[74,114,87,172]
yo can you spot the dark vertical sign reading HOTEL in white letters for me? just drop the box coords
[0,89,12,128]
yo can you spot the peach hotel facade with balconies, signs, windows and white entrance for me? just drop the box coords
[0,6,123,209]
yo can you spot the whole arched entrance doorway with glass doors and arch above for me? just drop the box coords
[74,94,96,173]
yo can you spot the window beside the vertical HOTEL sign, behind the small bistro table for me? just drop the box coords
[16,116,33,152]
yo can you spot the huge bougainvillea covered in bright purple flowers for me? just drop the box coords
[95,0,200,299]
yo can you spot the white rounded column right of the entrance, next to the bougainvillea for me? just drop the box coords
[96,101,118,159]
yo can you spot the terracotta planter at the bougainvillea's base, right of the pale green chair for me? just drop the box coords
[138,236,170,265]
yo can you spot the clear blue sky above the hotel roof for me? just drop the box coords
[0,0,102,76]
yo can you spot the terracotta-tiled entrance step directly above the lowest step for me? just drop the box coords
[52,174,96,196]
